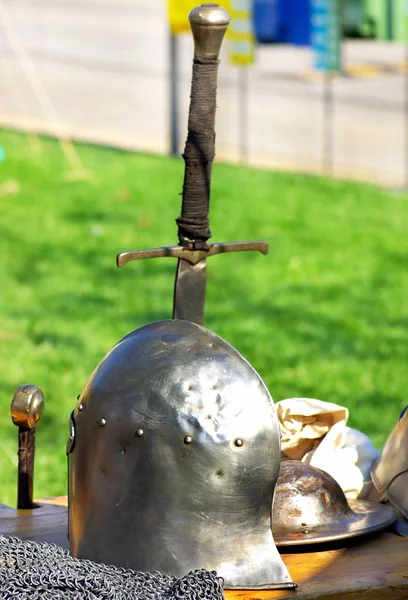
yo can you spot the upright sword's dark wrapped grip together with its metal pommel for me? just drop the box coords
[177,4,229,249]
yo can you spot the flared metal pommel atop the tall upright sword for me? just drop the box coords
[188,4,230,60]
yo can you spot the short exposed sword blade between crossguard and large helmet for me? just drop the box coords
[173,260,206,325]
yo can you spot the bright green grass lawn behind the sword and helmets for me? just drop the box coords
[0,132,408,505]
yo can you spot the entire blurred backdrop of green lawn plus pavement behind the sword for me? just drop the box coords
[0,0,408,505]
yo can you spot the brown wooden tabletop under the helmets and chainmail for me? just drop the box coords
[0,497,408,600]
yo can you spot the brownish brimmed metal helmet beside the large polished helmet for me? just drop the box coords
[272,460,396,546]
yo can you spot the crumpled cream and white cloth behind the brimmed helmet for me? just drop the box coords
[275,398,379,498]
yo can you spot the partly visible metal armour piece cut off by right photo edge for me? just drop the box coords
[371,407,408,519]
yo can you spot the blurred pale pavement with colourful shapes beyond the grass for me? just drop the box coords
[0,0,408,187]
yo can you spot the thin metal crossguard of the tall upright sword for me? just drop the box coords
[116,241,268,268]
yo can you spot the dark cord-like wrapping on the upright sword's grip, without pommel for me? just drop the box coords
[176,58,219,249]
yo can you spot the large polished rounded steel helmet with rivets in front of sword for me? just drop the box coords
[68,320,293,588]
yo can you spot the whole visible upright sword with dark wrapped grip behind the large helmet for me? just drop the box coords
[116,4,268,325]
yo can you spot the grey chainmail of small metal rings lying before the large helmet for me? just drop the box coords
[0,535,223,600]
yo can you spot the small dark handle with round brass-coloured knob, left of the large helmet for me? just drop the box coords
[11,384,44,508]
